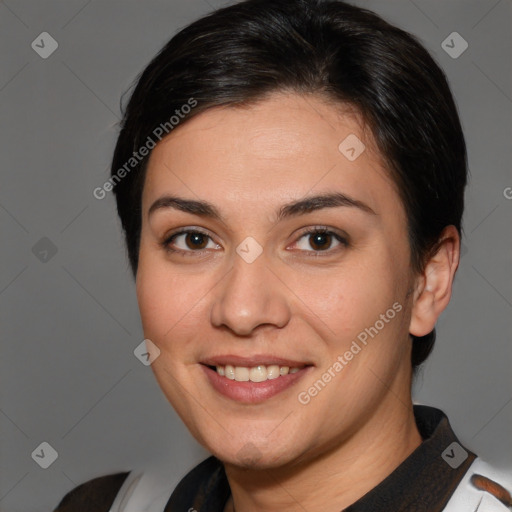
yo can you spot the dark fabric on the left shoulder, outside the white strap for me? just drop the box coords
[54,471,130,512]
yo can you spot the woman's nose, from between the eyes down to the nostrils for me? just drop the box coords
[211,249,290,336]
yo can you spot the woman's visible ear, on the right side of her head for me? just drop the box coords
[409,226,460,336]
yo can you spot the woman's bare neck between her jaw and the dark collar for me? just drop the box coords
[225,397,422,512]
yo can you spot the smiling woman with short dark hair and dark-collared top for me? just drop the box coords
[56,0,512,512]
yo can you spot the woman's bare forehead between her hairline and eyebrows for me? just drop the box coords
[143,94,398,218]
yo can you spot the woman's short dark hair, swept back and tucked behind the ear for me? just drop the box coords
[111,0,467,368]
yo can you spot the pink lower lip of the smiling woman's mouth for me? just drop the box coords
[201,364,313,404]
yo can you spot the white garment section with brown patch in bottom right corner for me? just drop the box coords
[443,457,512,512]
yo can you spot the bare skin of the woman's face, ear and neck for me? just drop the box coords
[136,93,459,512]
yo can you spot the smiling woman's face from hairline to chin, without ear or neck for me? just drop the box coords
[136,93,420,467]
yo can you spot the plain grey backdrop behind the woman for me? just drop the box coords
[0,0,512,512]
